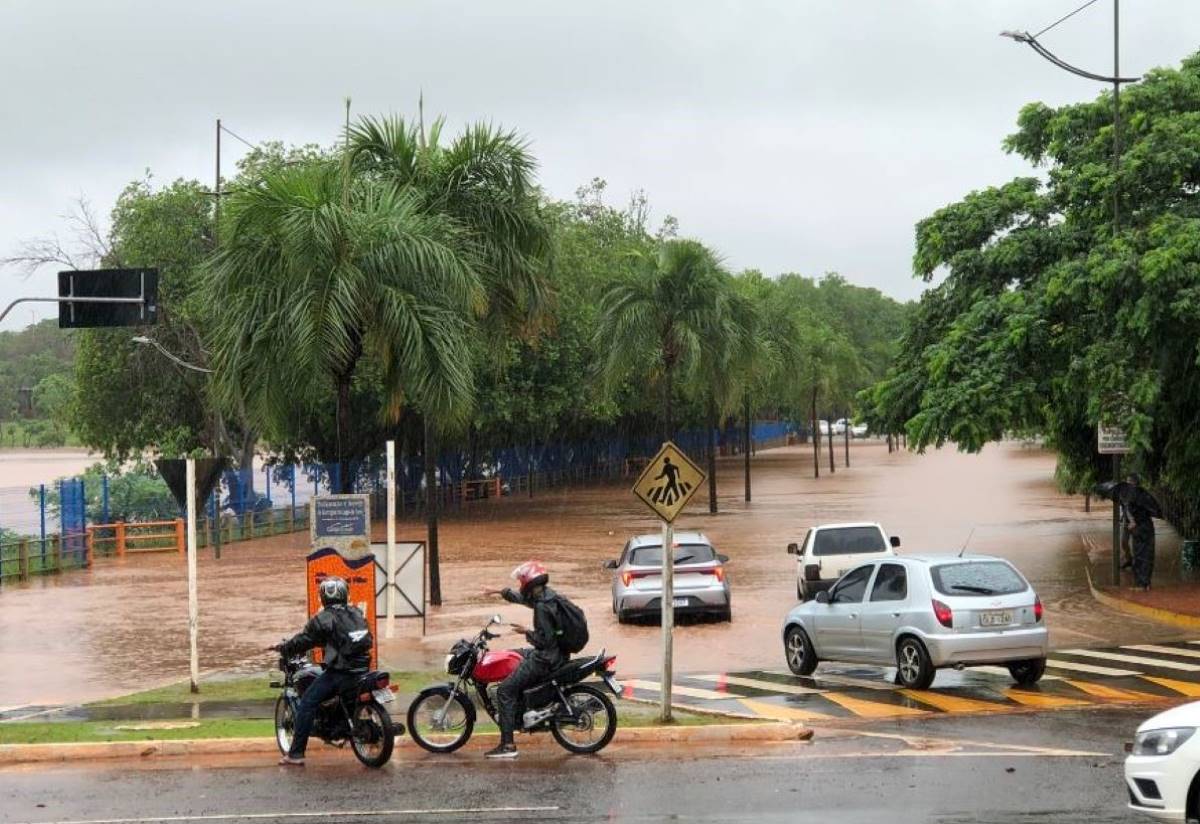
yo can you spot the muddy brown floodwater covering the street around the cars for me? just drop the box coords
[0,441,1178,708]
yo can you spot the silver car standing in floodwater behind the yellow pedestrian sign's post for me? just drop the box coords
[605,533,732,624]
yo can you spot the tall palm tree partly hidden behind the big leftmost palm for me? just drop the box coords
[348,116,550,605]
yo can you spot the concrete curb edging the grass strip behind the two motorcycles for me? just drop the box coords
[0,722,812,765]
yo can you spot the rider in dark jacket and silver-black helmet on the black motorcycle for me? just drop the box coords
[270,576,371,766]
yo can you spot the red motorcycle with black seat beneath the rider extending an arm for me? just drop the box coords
[408,615,620,754]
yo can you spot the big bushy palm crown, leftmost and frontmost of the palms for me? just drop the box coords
[206,160,482,492]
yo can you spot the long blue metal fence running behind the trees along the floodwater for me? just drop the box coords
[0,421,792,581]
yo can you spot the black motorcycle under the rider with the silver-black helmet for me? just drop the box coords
[271,656,404,768]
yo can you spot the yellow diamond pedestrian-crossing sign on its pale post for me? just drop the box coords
[634,441,706,721]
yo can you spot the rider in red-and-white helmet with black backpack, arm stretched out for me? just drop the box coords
[487,561,566,758]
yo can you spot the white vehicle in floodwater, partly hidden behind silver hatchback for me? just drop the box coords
[787,522,900,601]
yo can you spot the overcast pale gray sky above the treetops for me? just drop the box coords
[0,0,1200,329]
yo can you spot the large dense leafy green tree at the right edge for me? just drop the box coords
[870,56,1200,531]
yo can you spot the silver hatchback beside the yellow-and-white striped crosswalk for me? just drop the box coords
[784,555,1048,690]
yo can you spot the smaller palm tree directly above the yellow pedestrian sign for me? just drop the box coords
[596,240,730,440]
